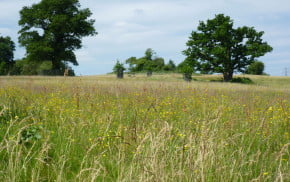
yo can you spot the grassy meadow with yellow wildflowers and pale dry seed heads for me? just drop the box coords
[0,74,290,182]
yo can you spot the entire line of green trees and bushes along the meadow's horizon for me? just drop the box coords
[0,0,273,81]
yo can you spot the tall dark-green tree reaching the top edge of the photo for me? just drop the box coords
[19,0,97,74]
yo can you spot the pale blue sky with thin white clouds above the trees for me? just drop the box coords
[0,0,290,76]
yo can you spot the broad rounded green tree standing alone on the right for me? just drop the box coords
[183,14,272,81]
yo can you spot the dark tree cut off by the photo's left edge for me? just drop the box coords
[0,36,15,75]
